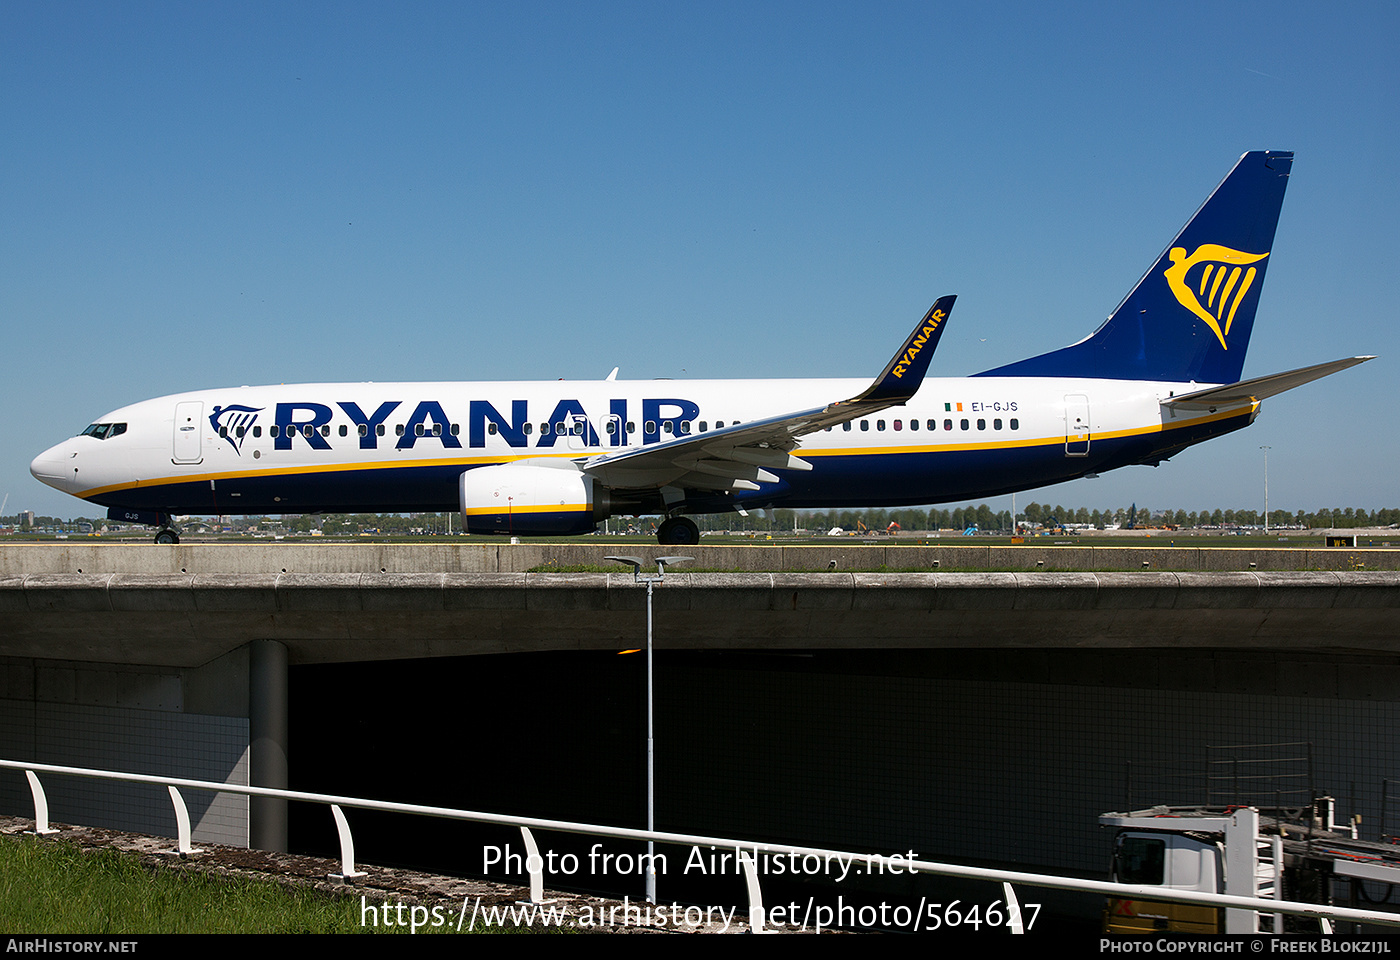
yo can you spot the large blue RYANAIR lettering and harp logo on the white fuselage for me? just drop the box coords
[242,397,700,452]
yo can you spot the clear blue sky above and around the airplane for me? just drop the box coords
[0,3,1400,516]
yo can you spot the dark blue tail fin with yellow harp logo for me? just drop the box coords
[977,151,1294,383]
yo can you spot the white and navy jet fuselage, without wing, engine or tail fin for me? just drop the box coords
[31,376,1257,523]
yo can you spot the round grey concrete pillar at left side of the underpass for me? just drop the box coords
[248,640,287,852]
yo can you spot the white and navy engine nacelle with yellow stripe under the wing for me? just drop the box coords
[458,460,610,536]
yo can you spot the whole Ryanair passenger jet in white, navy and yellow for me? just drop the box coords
[29,151,1371,544]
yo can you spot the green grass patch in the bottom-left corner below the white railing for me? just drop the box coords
[0,837,554,933]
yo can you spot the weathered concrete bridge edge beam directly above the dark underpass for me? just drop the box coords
[0,571,1400,666]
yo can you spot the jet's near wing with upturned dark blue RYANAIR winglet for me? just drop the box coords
[581,297,958,490]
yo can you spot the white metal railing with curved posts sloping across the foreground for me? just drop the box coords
[0,760,1400,933]
